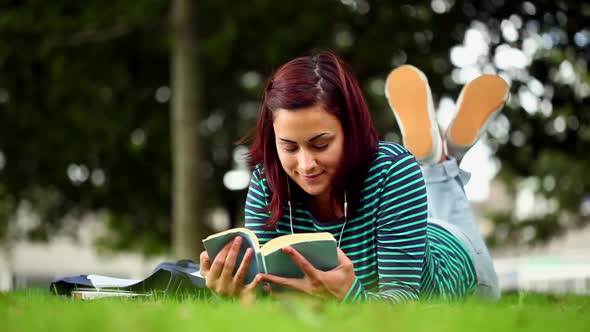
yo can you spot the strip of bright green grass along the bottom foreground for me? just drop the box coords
[0,290,590,332]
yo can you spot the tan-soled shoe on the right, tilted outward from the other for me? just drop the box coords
[445,75,509,160]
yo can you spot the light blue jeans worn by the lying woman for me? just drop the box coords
[422,158,500,300]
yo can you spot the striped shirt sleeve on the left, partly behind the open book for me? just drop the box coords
[244,167,279,246]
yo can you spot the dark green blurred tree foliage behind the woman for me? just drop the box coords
[0,0,590,253]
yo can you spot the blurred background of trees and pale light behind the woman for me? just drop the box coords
[0,0,590,294]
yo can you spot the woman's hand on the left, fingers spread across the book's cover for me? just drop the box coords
[199,236,261,302]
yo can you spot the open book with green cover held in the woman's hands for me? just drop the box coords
[203,228,338,284]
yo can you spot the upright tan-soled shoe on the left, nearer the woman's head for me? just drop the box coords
[385,65,443,164]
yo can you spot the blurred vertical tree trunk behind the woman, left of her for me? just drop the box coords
[170,0,205,259]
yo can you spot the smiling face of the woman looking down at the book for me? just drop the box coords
[273,105,344,199]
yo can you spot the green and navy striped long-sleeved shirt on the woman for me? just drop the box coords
[245,142,476,303]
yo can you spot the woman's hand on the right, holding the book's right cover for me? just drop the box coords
[261,247,356,300]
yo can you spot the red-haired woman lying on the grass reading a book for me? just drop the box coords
[200,53,507,302]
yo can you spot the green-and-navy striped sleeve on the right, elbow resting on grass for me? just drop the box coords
[343,153,428,303]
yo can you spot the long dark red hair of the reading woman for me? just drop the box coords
[249,52,378,227]
